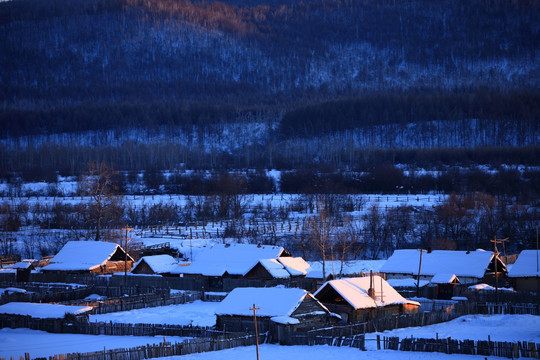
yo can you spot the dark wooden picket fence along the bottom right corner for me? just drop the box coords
[383,337,540,359]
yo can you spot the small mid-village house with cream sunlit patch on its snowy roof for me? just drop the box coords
[244,256,309,280]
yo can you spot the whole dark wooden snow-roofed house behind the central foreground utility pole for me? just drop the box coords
[216,286,336,343]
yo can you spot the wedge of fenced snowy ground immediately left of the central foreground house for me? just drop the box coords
[90,300,219,326]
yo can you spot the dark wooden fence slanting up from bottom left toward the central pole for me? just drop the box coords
[10,334,267,360]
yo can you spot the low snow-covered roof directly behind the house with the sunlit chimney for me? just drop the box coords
[306,260,386,279]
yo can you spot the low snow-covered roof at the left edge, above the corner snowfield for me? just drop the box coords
[0,302,92,319]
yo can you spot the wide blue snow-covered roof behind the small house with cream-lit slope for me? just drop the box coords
[172,244,285,276]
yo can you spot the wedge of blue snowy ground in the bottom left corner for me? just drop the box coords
[0,328,190,359]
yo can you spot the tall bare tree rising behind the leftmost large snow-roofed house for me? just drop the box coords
[78,161,120,241]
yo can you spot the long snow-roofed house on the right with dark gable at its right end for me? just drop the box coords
[380,249,506,284]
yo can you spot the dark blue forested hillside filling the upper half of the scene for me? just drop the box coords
[0,0,540,180]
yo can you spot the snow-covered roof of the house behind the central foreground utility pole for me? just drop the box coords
[216,287,309,317]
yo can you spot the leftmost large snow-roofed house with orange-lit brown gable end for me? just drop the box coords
[41,241,133,274]
